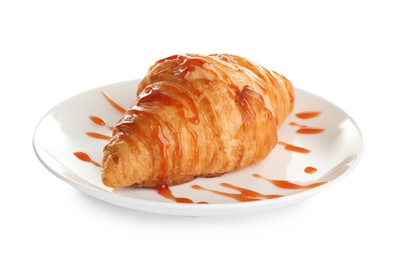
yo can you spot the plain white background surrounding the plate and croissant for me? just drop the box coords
[0,0,398,259]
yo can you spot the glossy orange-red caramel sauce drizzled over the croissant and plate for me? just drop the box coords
[74,58,326,204]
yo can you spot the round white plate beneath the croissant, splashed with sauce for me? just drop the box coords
[33,80,363,216]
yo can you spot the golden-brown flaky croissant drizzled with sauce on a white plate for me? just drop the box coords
[102,54,295,188]
